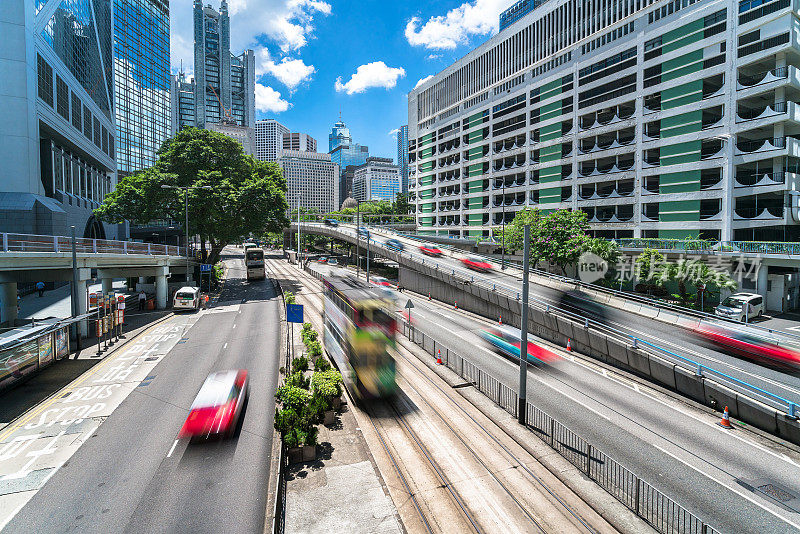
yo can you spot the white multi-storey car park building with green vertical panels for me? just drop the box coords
[408,0,800,241]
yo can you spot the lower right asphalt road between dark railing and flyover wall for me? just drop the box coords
[401,293,800,533]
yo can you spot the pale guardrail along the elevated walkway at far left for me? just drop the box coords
[0,232,186,256]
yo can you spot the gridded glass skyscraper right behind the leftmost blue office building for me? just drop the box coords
[114,0,170,174]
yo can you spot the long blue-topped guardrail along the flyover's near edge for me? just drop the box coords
[302,224,800,419]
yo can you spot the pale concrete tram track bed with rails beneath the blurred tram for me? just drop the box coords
[272,262,613,534]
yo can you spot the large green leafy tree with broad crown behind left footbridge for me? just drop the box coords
[95,128,288,263]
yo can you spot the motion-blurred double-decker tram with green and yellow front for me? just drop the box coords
[323,275,397,399]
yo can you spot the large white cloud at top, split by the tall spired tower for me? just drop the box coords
[170,0,331,71]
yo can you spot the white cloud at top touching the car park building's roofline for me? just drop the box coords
[405,0,510,50]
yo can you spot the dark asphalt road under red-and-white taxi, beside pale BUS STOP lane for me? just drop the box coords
[5,255,280,534]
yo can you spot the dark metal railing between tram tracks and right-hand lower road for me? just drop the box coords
[403,322,718,534]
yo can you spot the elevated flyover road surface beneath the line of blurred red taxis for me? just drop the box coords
[304,223,800,405]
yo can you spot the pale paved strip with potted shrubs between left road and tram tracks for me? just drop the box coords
[267,257,404,534]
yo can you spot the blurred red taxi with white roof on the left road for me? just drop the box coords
[178,369,247,438]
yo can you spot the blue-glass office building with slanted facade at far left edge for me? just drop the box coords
[0,0,126,238]
